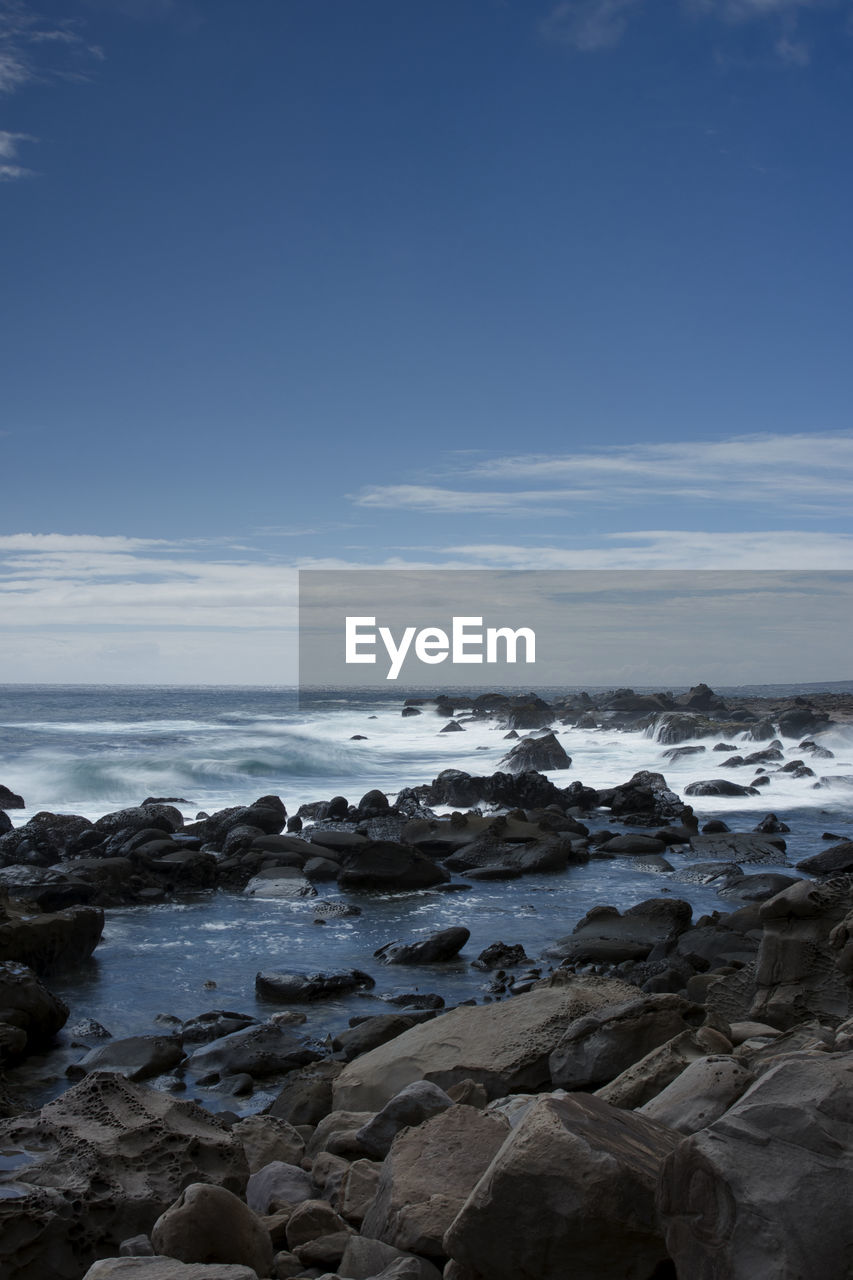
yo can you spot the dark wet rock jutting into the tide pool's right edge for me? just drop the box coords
[546,897,693,964]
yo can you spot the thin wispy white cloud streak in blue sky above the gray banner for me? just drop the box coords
[353,433,853,516]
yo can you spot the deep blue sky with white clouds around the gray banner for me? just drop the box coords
[0,0,853,684]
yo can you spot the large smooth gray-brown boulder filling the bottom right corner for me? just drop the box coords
[658,1053,853,1280]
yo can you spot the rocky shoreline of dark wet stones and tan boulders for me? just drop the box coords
[0,686,853,1280]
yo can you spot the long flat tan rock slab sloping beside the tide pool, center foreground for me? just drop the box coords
[334,978,637,1111]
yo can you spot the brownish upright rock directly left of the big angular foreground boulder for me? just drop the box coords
[361,1105,510,1258]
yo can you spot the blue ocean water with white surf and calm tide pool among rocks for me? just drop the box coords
[0,685,853,1110]
